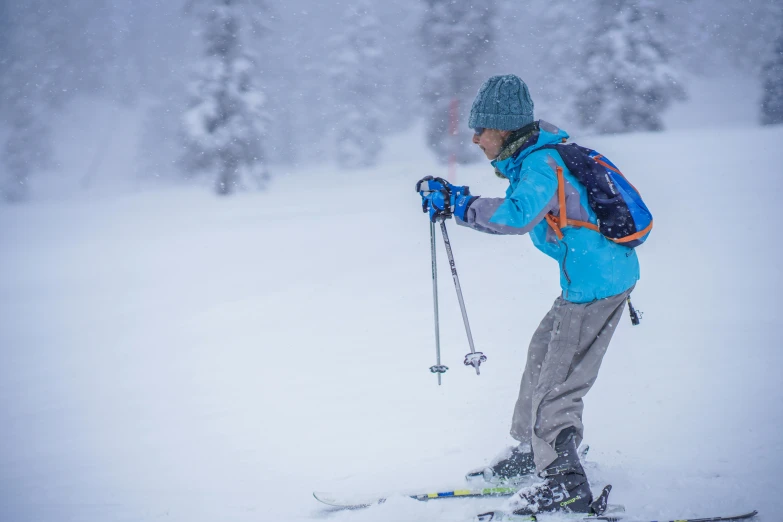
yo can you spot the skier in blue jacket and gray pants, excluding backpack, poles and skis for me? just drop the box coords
[420,75,639,514]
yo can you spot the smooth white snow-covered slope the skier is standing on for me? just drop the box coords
[0,122,783,522]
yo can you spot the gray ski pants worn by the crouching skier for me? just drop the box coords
[511,287,633,473]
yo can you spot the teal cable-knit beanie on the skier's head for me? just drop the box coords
[468,74,533,130]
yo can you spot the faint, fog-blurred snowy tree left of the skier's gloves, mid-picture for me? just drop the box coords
[328,0,385,168]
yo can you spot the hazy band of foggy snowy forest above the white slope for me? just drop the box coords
[0,0,783,202]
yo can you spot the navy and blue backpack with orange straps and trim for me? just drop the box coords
[541,143,653,248]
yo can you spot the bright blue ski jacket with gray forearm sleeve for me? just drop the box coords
[455,121,639,303]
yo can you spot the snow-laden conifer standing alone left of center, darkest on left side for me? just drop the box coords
[183,0,269,194]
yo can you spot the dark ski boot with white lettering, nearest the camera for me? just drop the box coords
[508,428,596,515]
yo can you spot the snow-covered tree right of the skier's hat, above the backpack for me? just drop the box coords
[575,0,685,133]
